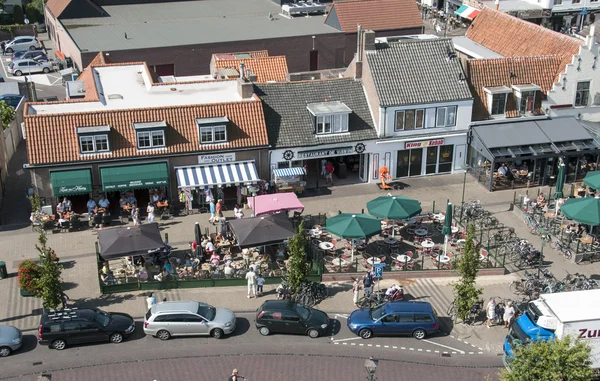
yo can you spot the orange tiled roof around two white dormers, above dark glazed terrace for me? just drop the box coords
[467,56,561,120]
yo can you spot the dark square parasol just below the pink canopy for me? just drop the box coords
[229,213,294,248]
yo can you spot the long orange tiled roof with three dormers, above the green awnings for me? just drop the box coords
[25,99,268,164]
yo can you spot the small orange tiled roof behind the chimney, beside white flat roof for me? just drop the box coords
[214,55,288,83]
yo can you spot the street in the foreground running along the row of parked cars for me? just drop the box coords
[0,314,501,381]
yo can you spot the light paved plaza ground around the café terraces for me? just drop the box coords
[0,174,600,352]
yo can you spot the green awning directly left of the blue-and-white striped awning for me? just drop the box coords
[100,163,169,191]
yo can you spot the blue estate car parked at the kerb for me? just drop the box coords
[347,301,439,340]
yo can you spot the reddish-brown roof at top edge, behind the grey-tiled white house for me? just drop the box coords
[325,0,423,33]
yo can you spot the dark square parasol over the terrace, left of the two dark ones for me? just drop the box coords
[98,223,165,260]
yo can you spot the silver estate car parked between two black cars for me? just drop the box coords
[144,301,235,340]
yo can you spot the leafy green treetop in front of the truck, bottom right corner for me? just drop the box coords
[499,336,594,381]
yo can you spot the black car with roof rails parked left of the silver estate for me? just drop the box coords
[38,308,135,350]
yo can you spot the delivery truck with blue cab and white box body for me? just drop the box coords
[504,290,600,370]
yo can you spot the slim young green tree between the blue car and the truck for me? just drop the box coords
[454,224,483,321]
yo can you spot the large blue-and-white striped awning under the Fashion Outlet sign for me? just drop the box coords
[176,161,259,188]
